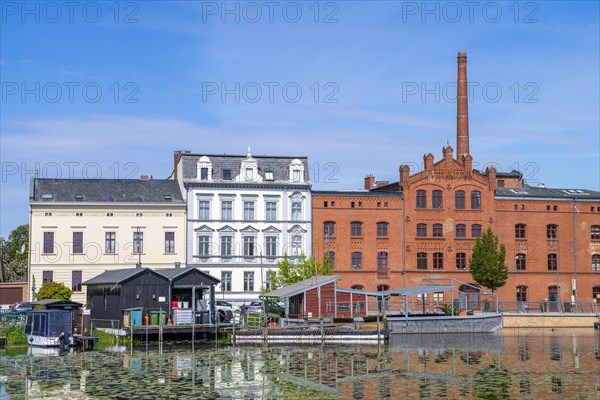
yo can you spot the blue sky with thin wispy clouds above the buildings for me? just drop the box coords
[0,1,600,236]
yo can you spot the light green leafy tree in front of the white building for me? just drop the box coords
[263,253,333,293]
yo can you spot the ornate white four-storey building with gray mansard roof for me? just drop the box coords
[174,149,312,302]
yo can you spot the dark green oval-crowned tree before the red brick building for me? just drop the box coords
[469,228,508,292]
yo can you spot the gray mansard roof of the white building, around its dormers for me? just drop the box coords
[180,153,310,183]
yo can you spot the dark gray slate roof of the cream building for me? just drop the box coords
[30,178,184,204]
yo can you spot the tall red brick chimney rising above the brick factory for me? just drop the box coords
[456,51,469,162]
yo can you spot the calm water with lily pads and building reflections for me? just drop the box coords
[0,329,600,400]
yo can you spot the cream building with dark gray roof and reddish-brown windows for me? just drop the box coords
[29,176,186,303]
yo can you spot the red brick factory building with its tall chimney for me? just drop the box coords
[312,52,600,306]
